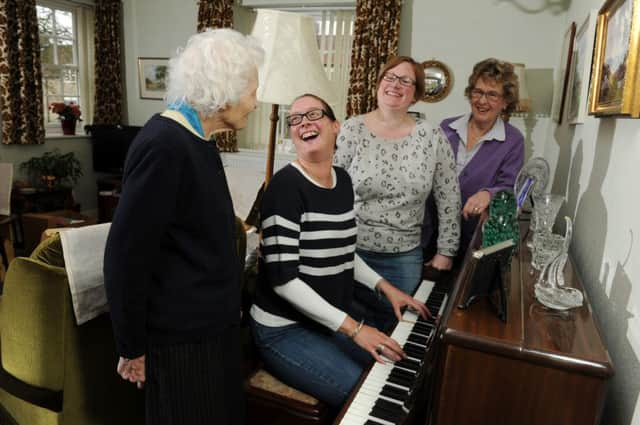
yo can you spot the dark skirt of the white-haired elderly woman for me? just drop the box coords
[145,327,244,425]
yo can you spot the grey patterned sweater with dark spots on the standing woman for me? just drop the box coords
[333,115,460,256]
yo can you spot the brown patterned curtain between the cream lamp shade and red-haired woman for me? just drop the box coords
[347,0,402,117]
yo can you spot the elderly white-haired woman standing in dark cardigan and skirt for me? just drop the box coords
[104,29,264,425]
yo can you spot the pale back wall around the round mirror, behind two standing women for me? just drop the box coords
[399,0,565,158]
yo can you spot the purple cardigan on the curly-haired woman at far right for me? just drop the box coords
[422,116,524,254]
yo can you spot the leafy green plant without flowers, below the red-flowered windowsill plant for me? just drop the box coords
[20,149,82,190]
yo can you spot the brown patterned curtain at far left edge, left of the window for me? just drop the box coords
[0,0,44,145]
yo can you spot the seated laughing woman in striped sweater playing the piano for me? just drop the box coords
[251,94,428,407]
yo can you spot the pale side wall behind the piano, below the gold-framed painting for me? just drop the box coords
[544,0,640,425]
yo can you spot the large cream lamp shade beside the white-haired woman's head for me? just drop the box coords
[251,9,335,105]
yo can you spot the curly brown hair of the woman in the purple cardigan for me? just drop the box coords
[464,58,519,116]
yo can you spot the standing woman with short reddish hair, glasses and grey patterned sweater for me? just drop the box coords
[334,56,460,327]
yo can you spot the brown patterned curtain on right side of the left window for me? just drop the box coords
[93,0,123,124]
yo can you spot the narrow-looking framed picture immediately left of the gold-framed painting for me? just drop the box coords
[566,9,598,124]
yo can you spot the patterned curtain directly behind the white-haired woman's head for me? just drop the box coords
[198,0,238,152]
